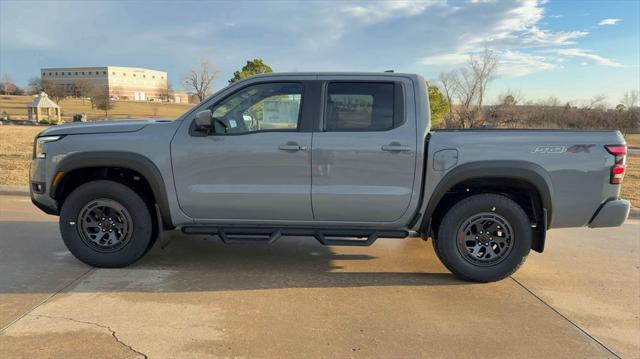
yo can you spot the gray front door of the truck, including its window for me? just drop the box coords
[171,82,313,221]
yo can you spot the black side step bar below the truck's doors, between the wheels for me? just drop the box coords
[182,226,409,246]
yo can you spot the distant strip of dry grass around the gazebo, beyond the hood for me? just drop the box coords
[0,96,193,121]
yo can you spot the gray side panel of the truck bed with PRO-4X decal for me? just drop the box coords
[425,129,625,228]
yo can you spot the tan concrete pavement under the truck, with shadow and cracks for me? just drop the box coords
[0,196,640,358]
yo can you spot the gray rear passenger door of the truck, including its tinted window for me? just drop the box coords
[312,76,417,222]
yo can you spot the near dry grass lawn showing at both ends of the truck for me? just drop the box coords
[0,125,640,207]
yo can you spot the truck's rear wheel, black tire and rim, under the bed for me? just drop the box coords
[433,194,531,282]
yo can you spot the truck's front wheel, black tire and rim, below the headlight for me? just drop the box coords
[60,180,153,268]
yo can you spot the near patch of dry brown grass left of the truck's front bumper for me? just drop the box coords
[0,125,46,186]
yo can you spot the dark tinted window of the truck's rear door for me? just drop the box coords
[325,82,394,131]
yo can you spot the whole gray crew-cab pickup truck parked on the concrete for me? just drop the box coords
[30,73,629,282]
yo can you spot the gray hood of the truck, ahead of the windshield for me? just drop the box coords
[38,119,169,137]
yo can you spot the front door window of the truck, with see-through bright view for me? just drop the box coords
[211,83,302,134]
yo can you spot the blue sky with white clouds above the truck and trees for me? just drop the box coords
[0,0,640,105]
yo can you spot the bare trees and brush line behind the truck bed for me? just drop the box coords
[429,49,640,133]
